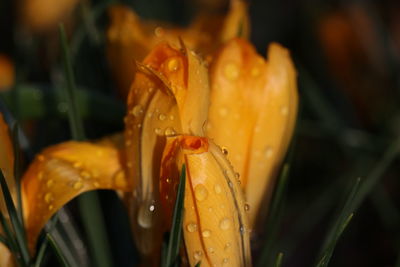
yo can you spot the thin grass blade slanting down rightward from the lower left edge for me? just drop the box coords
[0,172,30,265]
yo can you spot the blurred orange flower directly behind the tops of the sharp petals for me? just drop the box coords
[107,0,249,96]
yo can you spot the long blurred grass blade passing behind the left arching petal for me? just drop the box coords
[59,24,112,267]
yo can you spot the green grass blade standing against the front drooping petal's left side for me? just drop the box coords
[164,165,186,267]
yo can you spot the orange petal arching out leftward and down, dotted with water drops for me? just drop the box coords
[22,141,132,249]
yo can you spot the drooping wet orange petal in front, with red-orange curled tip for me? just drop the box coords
[160,136,251,266]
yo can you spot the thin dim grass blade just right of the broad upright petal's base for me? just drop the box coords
[257,163,290,267]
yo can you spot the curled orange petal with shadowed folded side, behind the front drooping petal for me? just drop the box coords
[125,43,209,255]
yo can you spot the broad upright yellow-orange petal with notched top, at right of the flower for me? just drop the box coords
[207,39,298,228]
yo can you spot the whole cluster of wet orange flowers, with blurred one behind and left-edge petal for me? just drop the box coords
[0,0,298,266]
